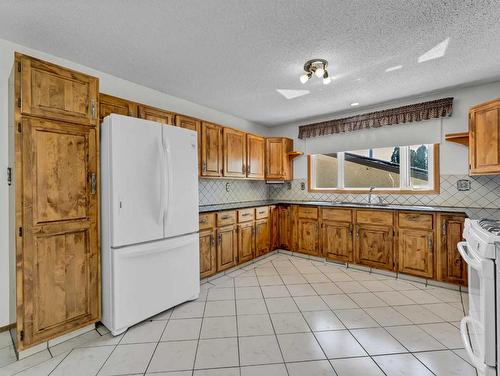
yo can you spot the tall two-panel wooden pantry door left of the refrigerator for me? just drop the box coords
[17,118,101,349]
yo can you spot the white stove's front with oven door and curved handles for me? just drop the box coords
[458,242,496,375]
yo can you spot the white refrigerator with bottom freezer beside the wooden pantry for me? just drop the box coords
[101,115,200,335]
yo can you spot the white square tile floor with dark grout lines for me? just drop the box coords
[0,253,476,376]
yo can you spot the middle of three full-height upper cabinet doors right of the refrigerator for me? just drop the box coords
[223,128,247,178]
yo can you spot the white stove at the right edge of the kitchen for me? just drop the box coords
[458,219,500,376]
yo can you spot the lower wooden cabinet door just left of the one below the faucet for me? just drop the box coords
[321,221,353,262]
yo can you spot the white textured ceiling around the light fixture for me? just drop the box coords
[0,0,500,125]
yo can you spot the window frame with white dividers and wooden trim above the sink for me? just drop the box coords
[307,144,440,194]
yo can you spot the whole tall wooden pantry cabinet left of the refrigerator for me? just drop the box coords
[9,53,101,350]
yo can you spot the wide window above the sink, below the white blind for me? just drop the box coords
[308,144,439,192]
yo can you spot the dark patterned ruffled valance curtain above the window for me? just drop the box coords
[299,98,453,139]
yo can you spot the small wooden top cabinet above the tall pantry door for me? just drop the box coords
[15,53,99,125]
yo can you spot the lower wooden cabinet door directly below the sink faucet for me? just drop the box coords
[355,224,394,270]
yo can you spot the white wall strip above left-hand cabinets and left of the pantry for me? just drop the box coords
[0,39,268,327]
